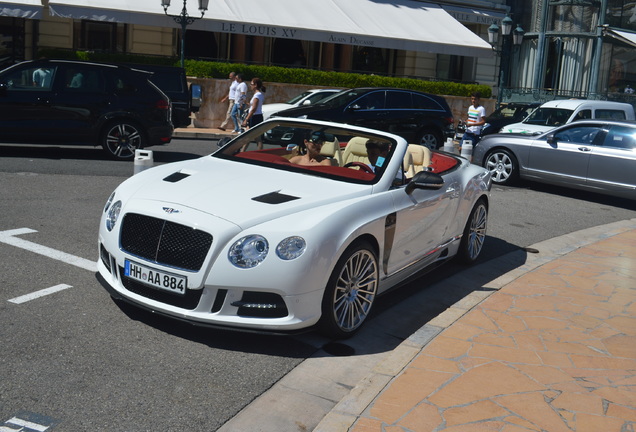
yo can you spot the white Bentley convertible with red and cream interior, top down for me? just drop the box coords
[98,118,491,338]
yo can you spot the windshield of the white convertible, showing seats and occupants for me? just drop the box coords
[212,119,397,184]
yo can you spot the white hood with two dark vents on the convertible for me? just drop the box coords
[120,156,372,229]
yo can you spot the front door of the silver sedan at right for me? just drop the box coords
[526,123,605,185]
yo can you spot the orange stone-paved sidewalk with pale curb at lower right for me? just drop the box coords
[175,128,636,432]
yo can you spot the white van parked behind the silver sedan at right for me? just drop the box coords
[500,99,636,134]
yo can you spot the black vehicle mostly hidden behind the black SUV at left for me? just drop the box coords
[120,64,201,128]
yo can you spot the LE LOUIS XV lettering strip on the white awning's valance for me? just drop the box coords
[221,22,375,46]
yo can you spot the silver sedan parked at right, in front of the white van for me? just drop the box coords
[473,120,636,199]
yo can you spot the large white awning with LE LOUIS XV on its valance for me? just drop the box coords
[49,0,492,57]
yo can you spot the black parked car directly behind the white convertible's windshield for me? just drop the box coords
[276,87,455,149]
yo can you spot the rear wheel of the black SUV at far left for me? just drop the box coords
[101,120,146,160]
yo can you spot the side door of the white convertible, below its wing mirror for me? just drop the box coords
[385,172,461,275]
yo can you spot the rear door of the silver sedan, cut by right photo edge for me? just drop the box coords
[587,125,636,198]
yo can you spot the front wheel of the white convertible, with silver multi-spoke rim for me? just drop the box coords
[318,242,379,339]
